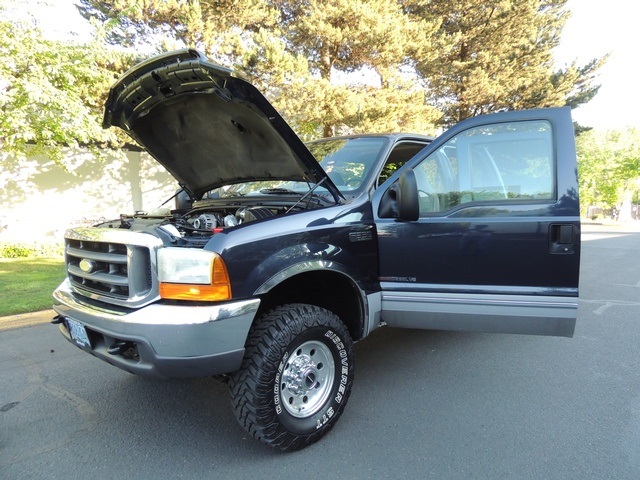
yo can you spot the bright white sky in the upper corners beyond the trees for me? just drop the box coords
[16,0,640,130]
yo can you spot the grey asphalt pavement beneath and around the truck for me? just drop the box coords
[0,225,640,479]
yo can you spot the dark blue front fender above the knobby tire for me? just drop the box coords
[206,197,379,298]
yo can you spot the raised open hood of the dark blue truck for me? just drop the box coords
[103,50,342,202]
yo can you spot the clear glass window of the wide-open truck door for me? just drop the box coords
[415,121,555,215]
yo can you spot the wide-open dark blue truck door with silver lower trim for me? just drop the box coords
[373,108,580,336]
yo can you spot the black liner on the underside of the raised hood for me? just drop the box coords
[133,93,313,197]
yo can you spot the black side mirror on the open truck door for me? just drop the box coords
[378,169,420,222]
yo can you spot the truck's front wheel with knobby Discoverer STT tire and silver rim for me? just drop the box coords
[230,304,354,451]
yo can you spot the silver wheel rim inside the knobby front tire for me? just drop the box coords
[280,340,335,418]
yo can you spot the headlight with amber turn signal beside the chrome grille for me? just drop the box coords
[158,248,231,301]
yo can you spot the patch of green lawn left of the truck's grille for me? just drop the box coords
[0,258,65,317]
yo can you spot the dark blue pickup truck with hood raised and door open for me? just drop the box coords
[53,50,580,450]
